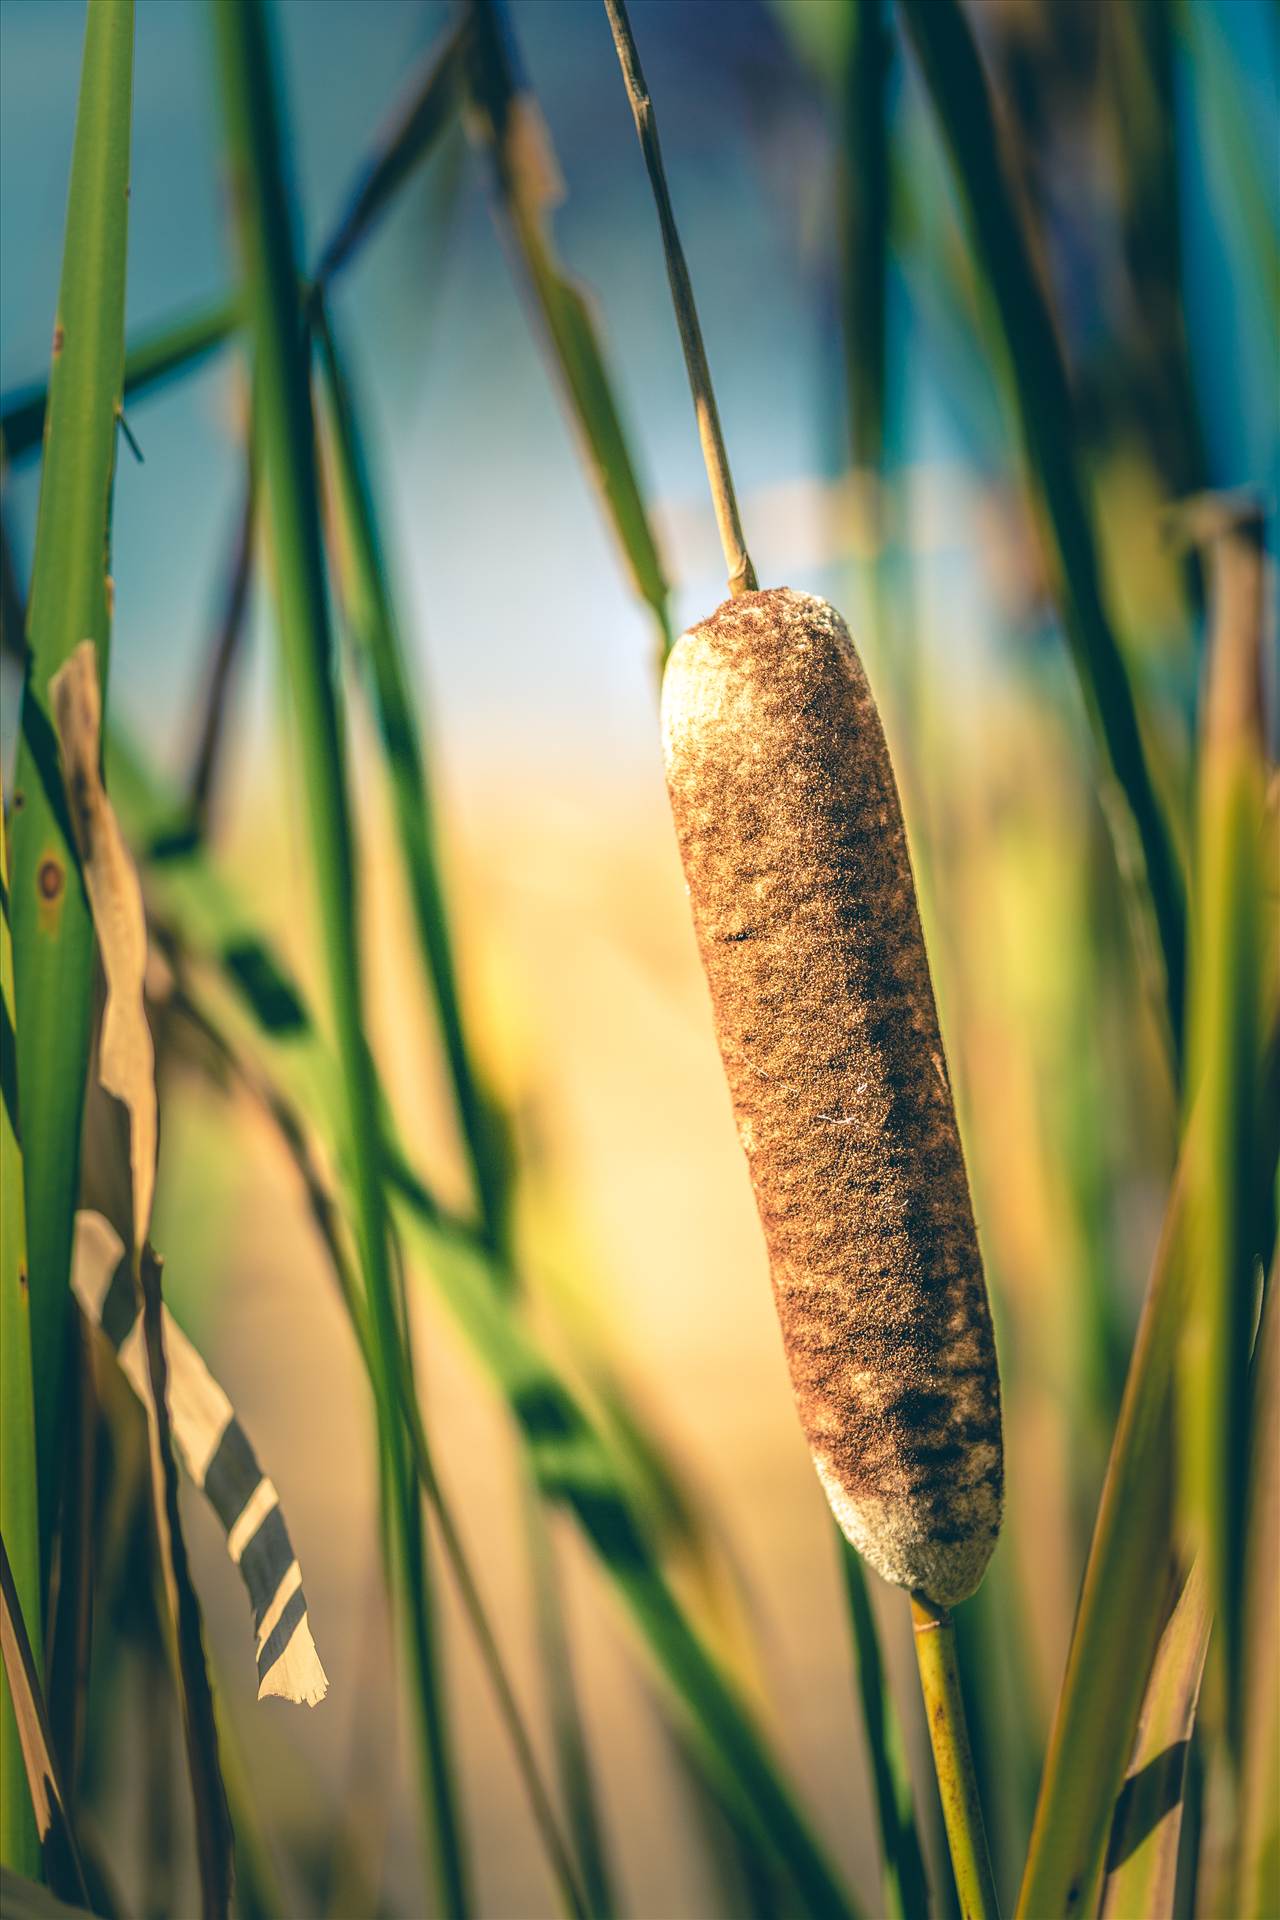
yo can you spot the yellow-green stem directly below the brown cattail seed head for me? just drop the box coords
[912,1594,1000,1920]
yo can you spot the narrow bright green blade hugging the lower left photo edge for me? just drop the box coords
[0,826,42,1878]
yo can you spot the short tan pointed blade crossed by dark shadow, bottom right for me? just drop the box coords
[1098,1565,1211,1920]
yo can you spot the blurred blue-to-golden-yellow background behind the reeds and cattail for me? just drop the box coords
[0,0,1280,1916]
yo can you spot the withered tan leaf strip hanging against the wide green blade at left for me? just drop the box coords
[50,639,159,1256]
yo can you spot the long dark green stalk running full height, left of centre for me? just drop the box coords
[213,0,468,1914]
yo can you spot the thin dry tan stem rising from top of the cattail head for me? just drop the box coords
[604,0,756,595]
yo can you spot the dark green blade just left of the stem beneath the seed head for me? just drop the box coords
[835,1528,929,1920]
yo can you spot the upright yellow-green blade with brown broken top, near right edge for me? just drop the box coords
[1178,499,1270,1759]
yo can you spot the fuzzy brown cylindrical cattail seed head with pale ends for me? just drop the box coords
[662,588,1004,1607]
